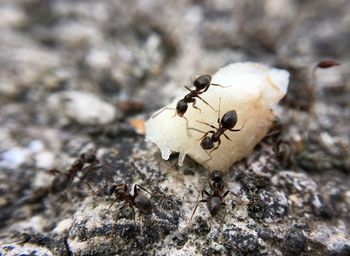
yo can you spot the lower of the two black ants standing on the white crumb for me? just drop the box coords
[188,98,245,161]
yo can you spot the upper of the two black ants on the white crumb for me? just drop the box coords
[152,75,225,127]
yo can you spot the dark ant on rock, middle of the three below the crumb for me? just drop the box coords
[104,183,152,221]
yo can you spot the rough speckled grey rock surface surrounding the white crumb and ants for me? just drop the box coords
[0,0,350,256]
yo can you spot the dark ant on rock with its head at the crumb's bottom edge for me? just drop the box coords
[188,171,242,223]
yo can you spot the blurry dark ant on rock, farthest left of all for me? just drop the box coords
[50,149,100,194]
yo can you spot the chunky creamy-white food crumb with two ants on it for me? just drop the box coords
[146,62,289,171]
